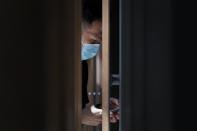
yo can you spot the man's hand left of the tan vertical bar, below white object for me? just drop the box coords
[81,105,102,126]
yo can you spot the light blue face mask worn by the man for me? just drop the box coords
[81,43,100,60]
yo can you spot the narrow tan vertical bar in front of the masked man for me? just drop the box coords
[102,0,110,131]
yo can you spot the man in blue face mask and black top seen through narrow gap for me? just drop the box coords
[81,0,119,126]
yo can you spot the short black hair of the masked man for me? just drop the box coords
[82,0,102,24]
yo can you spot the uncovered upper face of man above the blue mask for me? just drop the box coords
[82,21,102,44]
